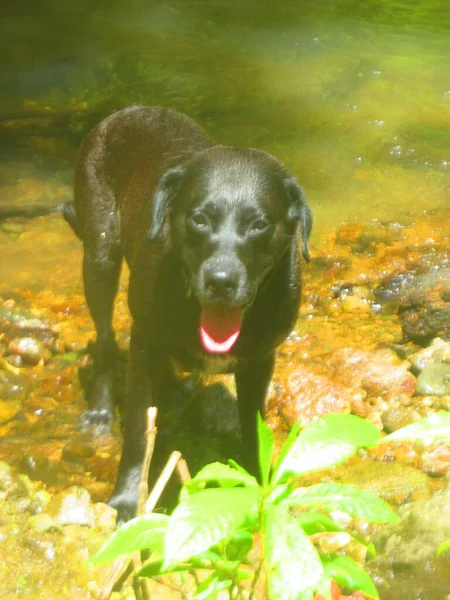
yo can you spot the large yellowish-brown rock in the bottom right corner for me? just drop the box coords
[369,486,450,600]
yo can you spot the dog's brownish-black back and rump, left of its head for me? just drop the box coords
[62,106,213,254]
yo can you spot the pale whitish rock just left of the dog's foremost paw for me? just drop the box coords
[45,486,95,527]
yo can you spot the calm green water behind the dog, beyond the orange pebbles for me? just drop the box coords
[0,0,450,244]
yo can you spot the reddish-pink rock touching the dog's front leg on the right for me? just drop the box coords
[267,368,358,428]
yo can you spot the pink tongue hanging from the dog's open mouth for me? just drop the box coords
[200,306,242,354]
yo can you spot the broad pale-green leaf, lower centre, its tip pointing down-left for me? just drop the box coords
[164,487,261,568]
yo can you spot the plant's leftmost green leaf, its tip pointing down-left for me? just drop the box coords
[89,513,169,565]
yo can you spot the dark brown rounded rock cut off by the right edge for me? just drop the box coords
[399,269,450,345]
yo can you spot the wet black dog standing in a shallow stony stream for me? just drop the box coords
[63,106,312,520]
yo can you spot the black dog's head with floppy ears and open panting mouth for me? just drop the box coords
[149,146,312,353]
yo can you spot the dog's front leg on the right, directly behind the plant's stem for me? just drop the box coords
[236,352,275,479]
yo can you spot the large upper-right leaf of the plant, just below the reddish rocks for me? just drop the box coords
[274,413,380,483]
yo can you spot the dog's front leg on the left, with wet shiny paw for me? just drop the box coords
[109,327,170,523]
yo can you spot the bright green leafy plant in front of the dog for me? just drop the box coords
[91,414,397,600]
